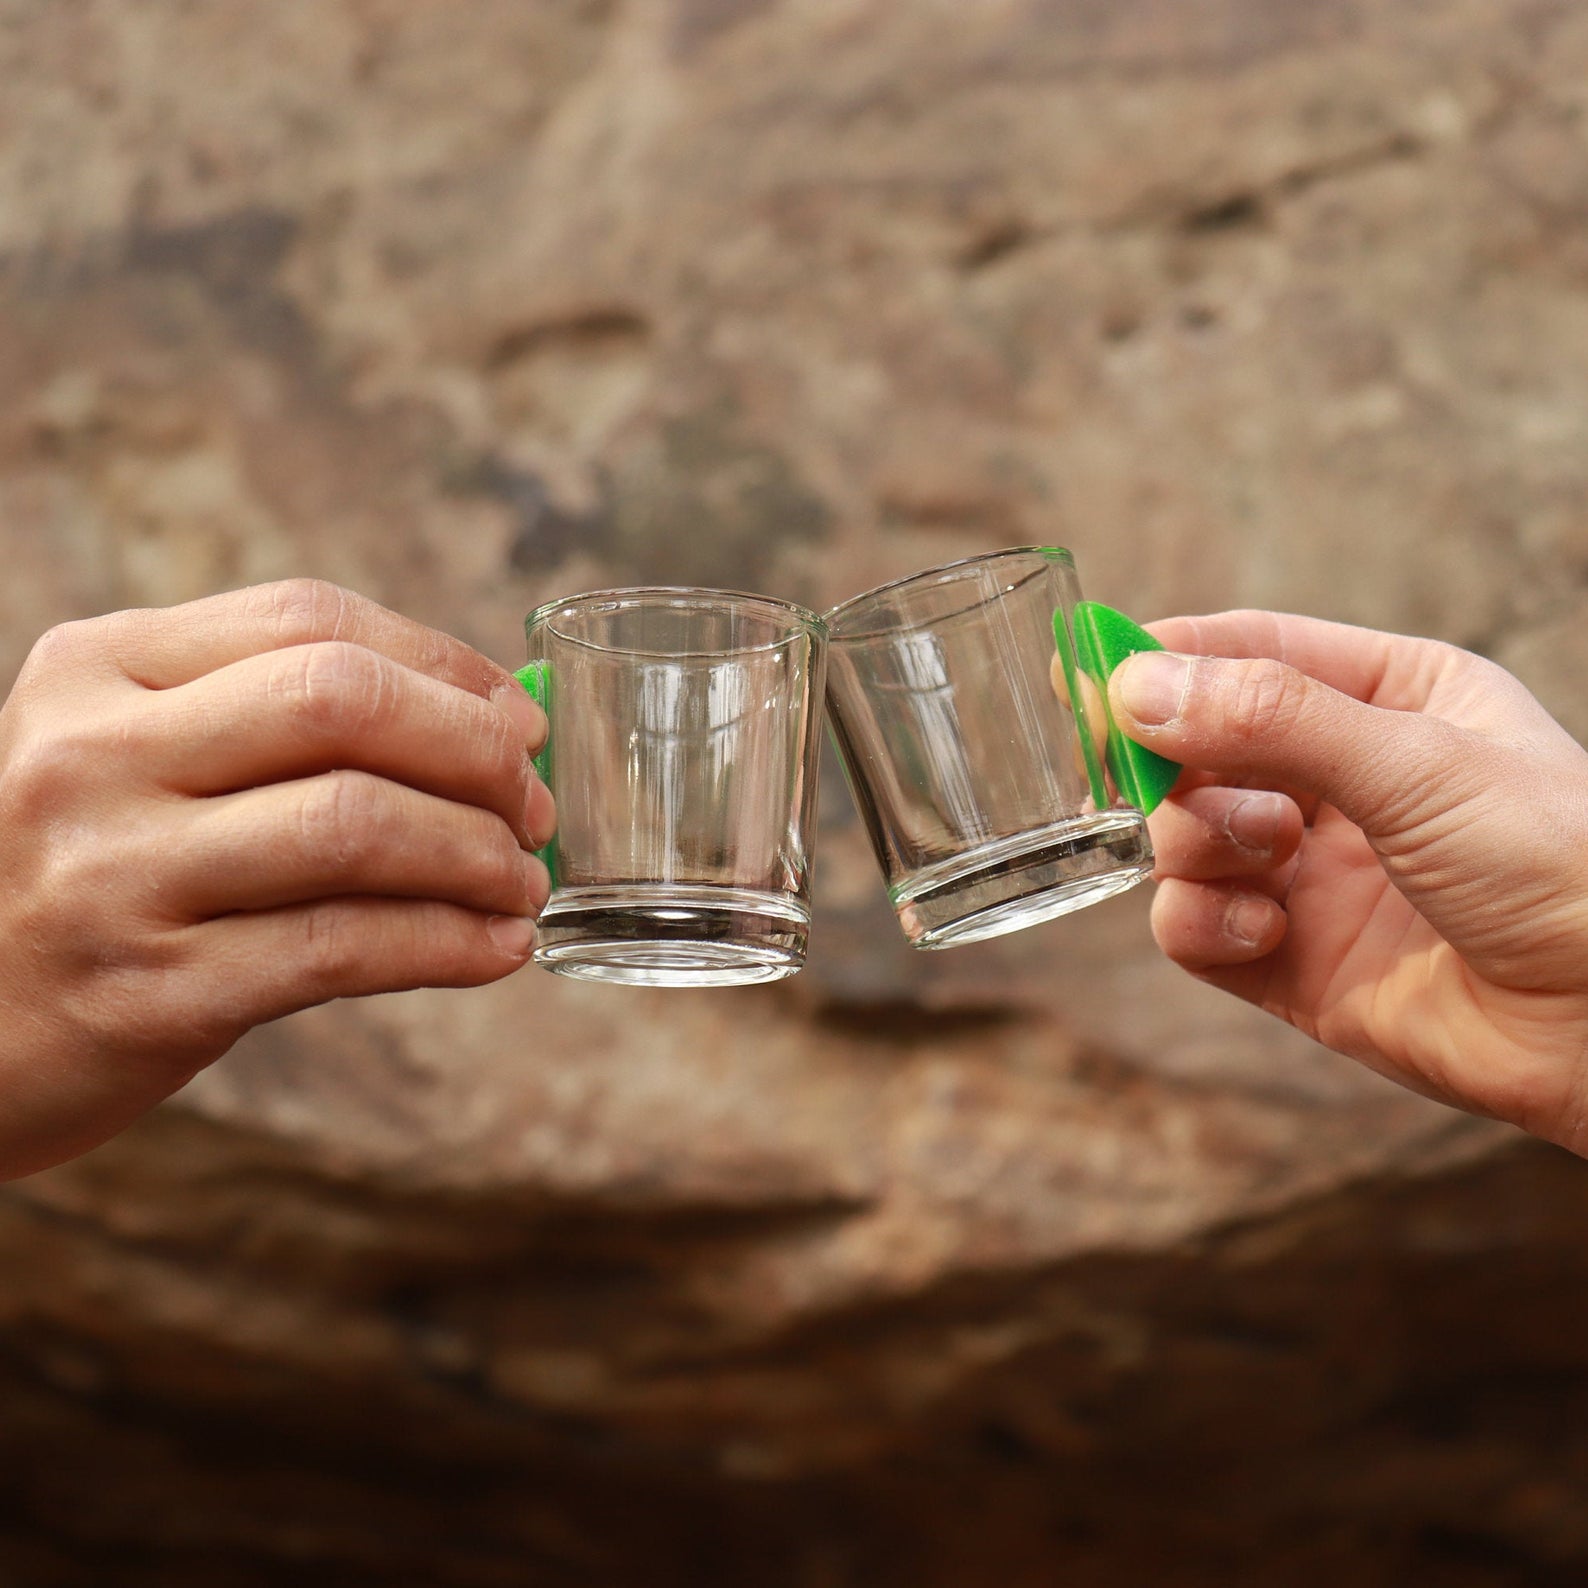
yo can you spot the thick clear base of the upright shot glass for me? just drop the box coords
[535,883,810,988]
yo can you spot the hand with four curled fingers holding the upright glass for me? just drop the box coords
[0,581,554,1178]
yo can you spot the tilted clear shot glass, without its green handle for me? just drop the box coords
[827,546,1153,948]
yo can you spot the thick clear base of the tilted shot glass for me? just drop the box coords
[892,810,1153,948]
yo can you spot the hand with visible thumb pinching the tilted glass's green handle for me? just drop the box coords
[1110,611,1588,1154]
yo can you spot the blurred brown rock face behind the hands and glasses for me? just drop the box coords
[0,0,1588,1588]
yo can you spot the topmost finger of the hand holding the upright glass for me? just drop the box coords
[100,580,522,700]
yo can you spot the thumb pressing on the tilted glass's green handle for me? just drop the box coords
[1108,651,1470,835]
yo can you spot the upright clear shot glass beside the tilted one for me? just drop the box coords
[521,589,827,986]
